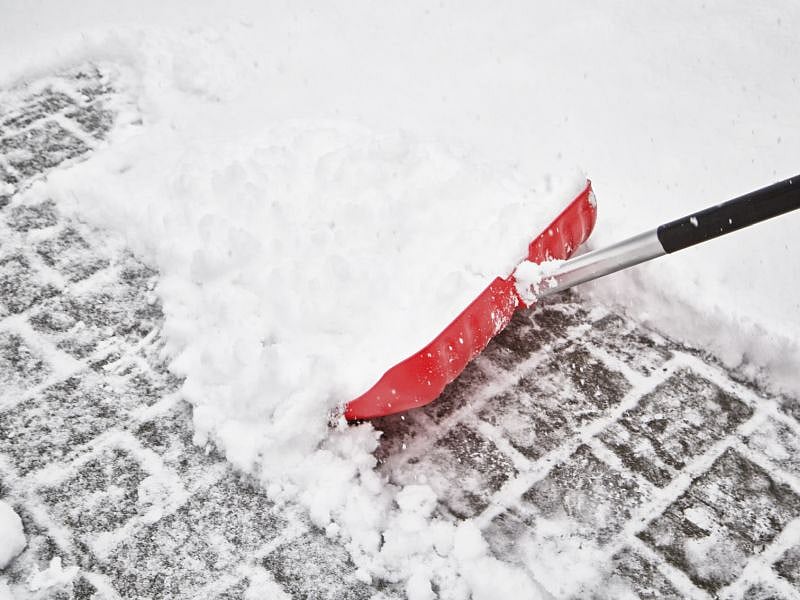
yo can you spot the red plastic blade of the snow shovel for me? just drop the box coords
[344,182,597,421]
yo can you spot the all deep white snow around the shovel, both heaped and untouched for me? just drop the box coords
[0,2,800,598]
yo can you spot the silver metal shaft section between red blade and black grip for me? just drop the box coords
[536,229,666,298]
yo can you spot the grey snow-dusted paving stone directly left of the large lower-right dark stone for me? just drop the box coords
[522,445,646,545]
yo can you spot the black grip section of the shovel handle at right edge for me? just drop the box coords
[657,175,800,254]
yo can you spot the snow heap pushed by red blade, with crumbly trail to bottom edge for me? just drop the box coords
[15,22,585,597]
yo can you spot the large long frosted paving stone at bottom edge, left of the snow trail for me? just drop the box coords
[98,474,284,598]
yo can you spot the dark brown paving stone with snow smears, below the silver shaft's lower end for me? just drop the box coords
[479,344,631,460]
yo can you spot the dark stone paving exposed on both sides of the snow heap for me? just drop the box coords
[0,66,800,599]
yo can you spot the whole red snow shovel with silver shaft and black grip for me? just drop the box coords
[345,171,800,421]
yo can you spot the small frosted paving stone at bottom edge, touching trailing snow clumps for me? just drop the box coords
[262,531,374,600]
